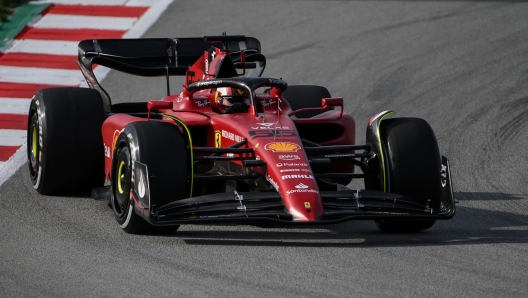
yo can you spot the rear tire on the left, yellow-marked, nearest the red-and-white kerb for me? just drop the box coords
[27,88,105,195]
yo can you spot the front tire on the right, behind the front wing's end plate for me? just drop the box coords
[376,118,442,233]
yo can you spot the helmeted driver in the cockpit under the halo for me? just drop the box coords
[213,88,249,114]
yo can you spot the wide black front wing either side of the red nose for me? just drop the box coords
[133,158,455,225]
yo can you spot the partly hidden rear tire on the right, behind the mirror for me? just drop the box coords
[282,85,333,118]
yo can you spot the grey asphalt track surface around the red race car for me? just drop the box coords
[0,0,528,297]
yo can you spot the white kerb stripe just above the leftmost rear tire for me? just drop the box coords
[0,66,84,86]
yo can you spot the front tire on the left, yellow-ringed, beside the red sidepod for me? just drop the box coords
[112,121,189,234]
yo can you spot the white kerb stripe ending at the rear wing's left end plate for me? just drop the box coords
[7,39,79,56]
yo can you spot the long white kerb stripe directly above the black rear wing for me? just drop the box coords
[33,14,137,30]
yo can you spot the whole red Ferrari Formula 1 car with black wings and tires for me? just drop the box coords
[27,34,455,233]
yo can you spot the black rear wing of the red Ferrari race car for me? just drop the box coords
[77,36,261,112]
